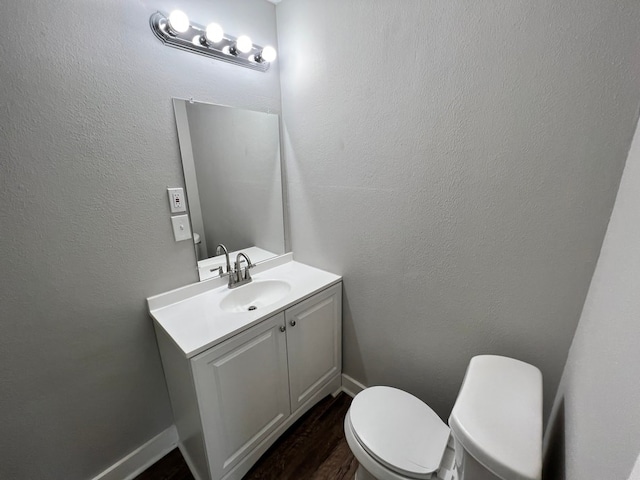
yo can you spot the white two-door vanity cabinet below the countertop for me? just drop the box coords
[156,282,342,480]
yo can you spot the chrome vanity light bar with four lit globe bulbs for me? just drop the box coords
[149,10,277,72]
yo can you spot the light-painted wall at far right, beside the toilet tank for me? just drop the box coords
[554,117,640,480]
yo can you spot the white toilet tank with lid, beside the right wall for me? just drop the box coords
[449,355,542,480]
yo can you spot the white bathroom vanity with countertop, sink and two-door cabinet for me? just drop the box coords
[148,253,342,480]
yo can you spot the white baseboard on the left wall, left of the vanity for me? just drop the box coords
[93,425,178,480]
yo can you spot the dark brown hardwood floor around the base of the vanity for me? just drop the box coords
[135,393,358,480]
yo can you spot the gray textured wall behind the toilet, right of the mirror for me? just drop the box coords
[277,0,640,418]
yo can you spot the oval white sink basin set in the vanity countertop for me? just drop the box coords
[220,280,291,313]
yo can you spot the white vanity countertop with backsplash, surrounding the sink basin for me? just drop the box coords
[147,254,342,358]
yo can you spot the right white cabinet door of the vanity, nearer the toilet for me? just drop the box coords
[285,283,342,412]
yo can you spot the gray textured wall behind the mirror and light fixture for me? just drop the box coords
[0,0,280,480]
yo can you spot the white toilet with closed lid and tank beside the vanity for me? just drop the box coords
[344,355,542,480]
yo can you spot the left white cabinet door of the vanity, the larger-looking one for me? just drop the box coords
[192,313,291,480]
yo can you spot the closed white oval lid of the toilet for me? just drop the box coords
[349,387,449,478]
